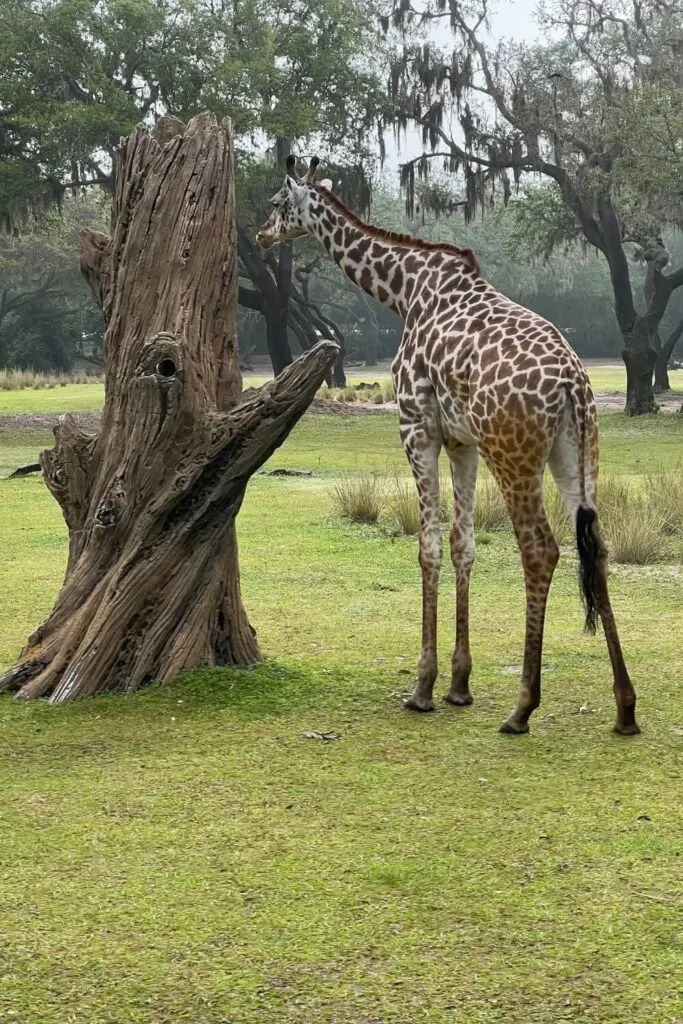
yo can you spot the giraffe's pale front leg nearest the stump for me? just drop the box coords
[399,417,441,711]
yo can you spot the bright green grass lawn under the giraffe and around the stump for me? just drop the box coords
[0,403,683,1024]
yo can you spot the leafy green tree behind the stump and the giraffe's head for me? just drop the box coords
[0,0,381,378]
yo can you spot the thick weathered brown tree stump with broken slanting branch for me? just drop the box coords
[0,115,337,703]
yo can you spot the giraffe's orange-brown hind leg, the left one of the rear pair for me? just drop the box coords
[492,465,559,734]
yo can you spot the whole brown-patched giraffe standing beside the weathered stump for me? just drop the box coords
[256,157,640,735]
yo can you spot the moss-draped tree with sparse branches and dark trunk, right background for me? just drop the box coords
[383,0,683,415]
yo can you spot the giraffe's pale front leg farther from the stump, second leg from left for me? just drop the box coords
[443,443,479,707]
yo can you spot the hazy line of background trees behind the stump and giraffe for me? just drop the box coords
[0,0,683,413]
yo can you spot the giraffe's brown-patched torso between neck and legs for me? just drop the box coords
[396,272,592,470]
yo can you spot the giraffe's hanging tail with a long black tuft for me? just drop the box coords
[568,378,604,633]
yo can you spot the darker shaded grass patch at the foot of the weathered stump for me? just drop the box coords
[0,662,352,776]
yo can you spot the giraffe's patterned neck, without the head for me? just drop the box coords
[306,191,475,318]
